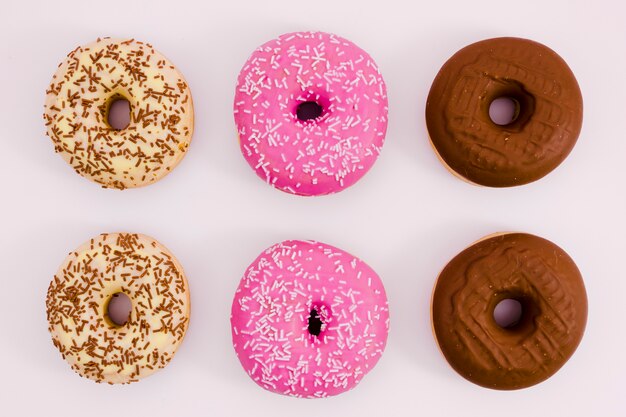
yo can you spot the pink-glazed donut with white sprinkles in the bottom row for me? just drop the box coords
[231,240,389,398]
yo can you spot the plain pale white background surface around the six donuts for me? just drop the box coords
[0,0,626,417]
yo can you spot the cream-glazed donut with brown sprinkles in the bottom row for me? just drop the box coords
[46,233,190,384]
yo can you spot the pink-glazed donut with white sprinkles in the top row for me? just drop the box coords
[234,32,387,196]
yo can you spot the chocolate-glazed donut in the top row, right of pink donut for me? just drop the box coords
[426,38,583,187]
